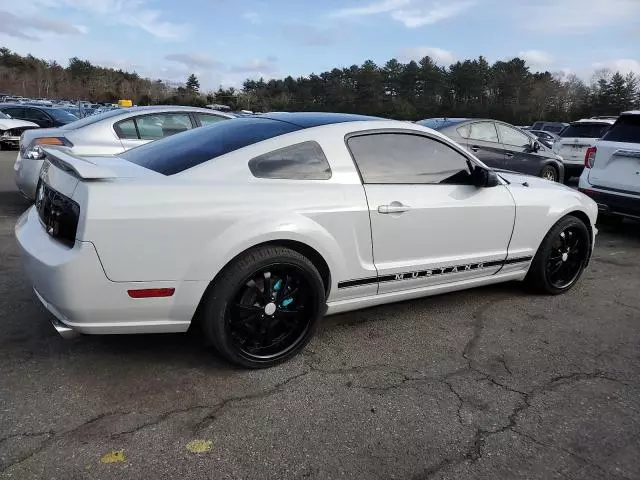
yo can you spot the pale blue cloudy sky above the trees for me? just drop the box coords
[0,0,640,89]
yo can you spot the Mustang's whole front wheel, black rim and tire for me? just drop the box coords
[526,215,591,295]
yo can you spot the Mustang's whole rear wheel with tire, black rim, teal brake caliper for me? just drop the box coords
[201,246,326,368]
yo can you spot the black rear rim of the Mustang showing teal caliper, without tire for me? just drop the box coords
[226,264,317,360]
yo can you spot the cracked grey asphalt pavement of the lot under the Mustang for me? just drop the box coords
[0,148,640,480]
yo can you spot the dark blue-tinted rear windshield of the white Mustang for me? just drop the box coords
[120,117,302,175]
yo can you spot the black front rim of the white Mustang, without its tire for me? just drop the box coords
[547,226,589,290]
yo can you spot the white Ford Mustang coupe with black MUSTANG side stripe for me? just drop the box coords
[16,113,597,367]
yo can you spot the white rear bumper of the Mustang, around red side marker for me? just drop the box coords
[15,207,206,337]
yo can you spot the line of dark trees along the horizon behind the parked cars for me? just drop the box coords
[0,48,640,124]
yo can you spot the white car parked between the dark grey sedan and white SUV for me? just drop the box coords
[553,118,615,180]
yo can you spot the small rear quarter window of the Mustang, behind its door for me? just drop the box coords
[249,142,331,180]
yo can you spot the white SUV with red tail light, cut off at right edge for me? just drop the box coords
[579,110,640,219]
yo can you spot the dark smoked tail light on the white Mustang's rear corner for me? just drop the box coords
[36,180,80,247]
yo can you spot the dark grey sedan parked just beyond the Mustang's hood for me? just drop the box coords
[418,118,564,182]
